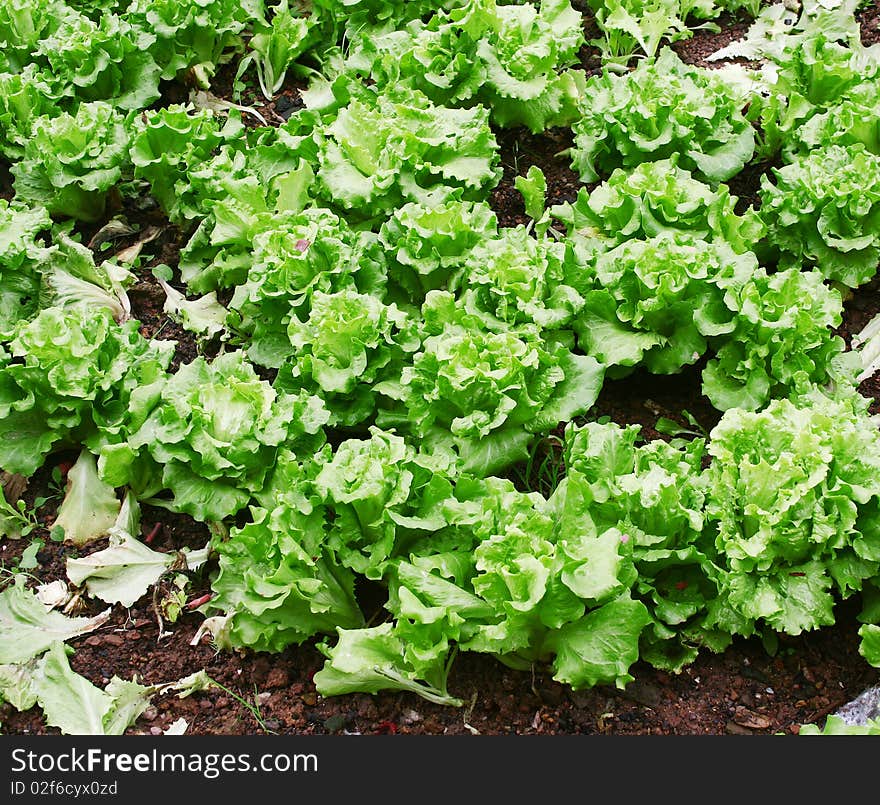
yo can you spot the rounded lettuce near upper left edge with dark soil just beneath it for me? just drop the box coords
[11,101,130,222]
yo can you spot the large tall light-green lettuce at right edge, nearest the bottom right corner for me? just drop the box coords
[706,394,880,635]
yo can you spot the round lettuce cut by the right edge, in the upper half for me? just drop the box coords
[760,143,880,288]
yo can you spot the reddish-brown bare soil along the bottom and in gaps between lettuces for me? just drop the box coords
[0,3,880,735]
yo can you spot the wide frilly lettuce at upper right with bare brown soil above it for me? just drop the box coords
[570,48,755,182]
